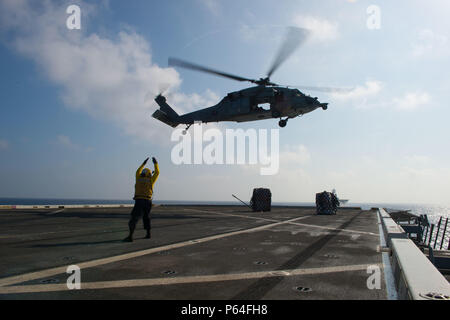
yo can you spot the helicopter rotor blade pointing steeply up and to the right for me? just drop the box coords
[267,27,309,78]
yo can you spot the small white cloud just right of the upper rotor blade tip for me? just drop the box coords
[292,14,339,41]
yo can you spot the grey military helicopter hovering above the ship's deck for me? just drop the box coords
[152,27,346,134]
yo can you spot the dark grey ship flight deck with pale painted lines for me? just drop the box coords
[0,206,387,300]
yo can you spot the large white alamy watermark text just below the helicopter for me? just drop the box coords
[170,124,280,175]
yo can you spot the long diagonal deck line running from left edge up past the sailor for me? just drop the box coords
[0,217,302,287]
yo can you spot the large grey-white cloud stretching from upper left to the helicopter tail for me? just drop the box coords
[0,0,218,141]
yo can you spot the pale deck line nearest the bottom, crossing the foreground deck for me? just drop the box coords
[0,264,382,294]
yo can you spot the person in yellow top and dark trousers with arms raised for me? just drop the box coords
[123,158,159,242]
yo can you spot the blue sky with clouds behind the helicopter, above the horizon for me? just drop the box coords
[0,0,450,203]
